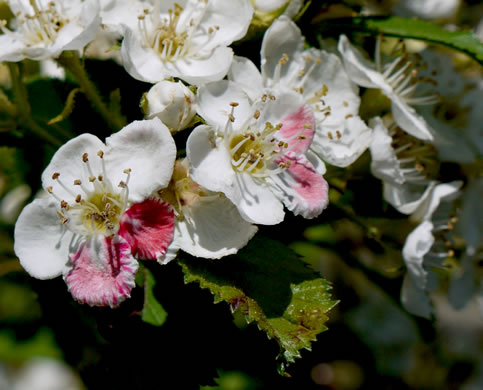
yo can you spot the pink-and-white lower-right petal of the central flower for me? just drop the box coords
[270,153,329,218]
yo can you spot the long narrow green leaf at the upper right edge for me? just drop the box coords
[319,16,483,64]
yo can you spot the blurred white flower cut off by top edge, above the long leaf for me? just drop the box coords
[393,0,461,20]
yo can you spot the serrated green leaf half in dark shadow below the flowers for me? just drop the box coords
[179,238,337,373]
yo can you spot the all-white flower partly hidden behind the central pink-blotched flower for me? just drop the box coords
[229,16,371,167]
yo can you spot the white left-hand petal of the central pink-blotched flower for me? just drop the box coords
[186,125,235,192]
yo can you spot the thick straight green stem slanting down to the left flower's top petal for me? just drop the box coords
[57,51,126,131]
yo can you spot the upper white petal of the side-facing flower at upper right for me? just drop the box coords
[338,35,392,91]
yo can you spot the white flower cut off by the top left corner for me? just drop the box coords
[0,0,101,62]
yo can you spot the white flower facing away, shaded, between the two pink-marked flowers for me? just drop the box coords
[159,159,258,263]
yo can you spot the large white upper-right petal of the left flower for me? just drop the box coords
[104,118,176,202]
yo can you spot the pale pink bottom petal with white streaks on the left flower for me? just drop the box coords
[64,236,138,308]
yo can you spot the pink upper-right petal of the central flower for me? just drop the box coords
[277,104,315,155]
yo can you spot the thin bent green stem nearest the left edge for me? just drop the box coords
[7,62,62,147]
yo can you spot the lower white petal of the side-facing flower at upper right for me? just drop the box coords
[394,93,433,141]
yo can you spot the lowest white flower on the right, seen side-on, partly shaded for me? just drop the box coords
[401,182,462,318]
